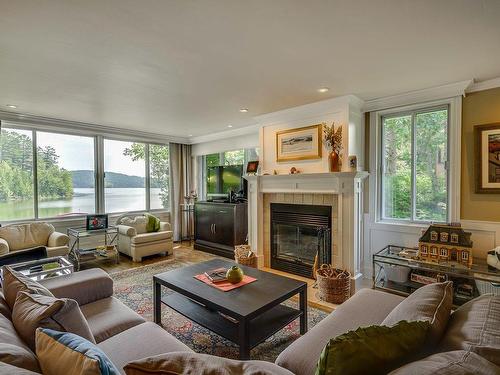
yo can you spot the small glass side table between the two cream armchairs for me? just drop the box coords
[68,227,120,271]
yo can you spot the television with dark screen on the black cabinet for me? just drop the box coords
[207,165,243,198]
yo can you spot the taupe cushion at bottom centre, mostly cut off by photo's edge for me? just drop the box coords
[124,352,292,375]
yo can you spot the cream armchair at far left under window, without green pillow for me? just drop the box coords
[0,222,69,257]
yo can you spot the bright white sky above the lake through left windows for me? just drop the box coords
[37,132,145,177]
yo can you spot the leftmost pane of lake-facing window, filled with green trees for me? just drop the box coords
[0,128,35,220]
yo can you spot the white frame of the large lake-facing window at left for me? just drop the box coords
[1,121,170,224]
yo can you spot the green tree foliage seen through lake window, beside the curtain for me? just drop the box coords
[123,143,170,208]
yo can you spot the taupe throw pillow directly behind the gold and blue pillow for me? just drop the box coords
[12,292,95,350]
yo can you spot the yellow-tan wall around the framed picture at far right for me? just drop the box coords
[460,88,500,221]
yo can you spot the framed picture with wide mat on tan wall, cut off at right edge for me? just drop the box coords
[474,123,500,194]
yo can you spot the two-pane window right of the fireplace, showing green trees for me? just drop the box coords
[381,106,449,222]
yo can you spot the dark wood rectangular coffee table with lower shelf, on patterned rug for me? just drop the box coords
[153,259,307,359]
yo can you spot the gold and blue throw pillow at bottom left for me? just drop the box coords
[36,328,120,375]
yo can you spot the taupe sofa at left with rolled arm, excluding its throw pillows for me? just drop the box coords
[0,268,292,375]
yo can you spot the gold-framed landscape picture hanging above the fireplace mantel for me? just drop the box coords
[276,124,323,162]
